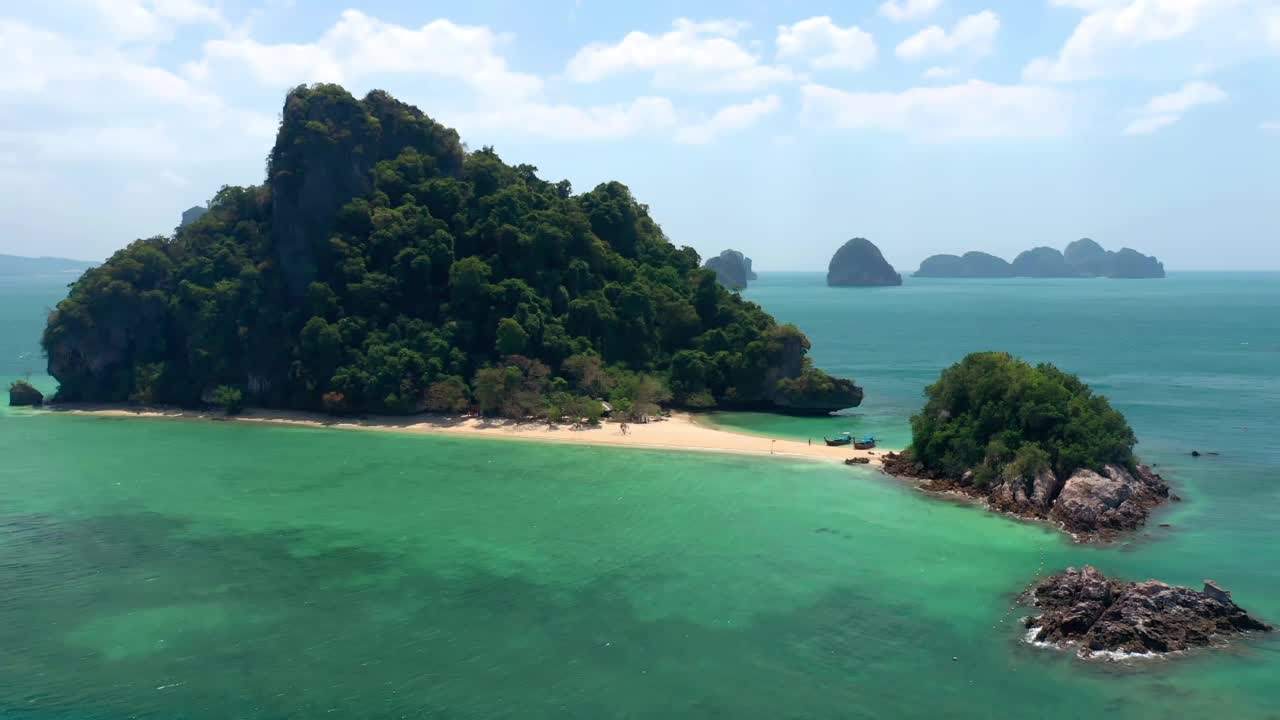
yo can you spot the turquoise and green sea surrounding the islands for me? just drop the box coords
[0,273,1280,720]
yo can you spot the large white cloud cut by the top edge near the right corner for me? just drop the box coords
[1023,0,1247,82]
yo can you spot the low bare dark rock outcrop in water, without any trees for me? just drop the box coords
[1024,565,1271,657]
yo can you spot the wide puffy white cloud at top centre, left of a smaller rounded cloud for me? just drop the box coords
[566,19,794,92]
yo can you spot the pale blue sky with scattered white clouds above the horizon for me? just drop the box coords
[0,0,1280,272]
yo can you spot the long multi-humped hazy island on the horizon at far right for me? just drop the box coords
[914,238,1165,278]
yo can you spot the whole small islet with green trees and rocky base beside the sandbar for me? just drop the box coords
[884,352,1178,541]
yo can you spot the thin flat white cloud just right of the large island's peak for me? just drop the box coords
[452,97,677,141]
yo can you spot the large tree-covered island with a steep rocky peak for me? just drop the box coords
[42,85,863,421]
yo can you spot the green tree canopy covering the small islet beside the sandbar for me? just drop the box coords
[911,352,1137,484]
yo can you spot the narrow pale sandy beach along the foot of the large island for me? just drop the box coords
[50,405,891,466]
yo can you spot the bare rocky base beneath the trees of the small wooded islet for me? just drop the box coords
[884,452,1170,541]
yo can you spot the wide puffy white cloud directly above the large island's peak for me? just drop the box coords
[187,10,541,100]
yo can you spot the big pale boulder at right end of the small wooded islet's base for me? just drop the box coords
[1050,465,1169,534]
